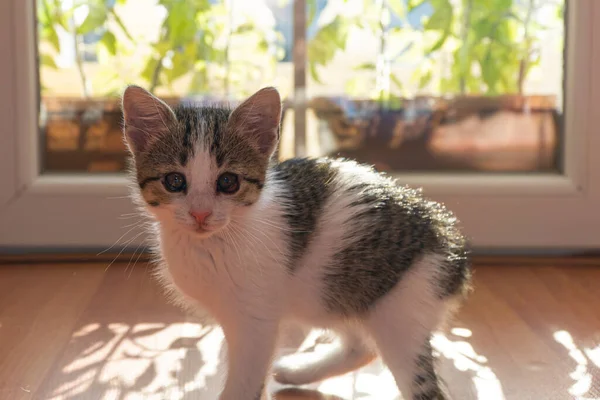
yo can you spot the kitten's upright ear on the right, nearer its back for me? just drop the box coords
[228,87,281,156]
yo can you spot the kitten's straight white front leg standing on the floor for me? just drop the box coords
[219,317,279,400]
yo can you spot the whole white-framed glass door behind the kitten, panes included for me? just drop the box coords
[0,0,600,251]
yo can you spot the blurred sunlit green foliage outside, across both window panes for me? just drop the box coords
[37,0,564,101]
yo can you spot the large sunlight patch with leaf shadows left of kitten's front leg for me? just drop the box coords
[51,323,223,400]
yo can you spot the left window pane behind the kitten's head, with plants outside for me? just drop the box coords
[36,0,292,173]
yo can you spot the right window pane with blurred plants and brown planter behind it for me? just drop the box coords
[306,0,565,173]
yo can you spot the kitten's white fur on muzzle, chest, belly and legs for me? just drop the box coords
[154,152,454,400]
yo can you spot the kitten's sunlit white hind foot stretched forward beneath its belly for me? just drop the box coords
[273,332,376,385]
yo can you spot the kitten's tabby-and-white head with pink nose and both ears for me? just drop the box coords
[123,86,281,237]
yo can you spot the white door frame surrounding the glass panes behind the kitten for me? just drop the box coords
[0,0,600,252]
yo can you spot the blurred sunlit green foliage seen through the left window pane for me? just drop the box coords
[37,0,283,96]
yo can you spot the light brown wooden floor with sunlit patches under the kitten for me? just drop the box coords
[0,261,600,400]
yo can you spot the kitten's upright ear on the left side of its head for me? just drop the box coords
[123,86,176,155]
